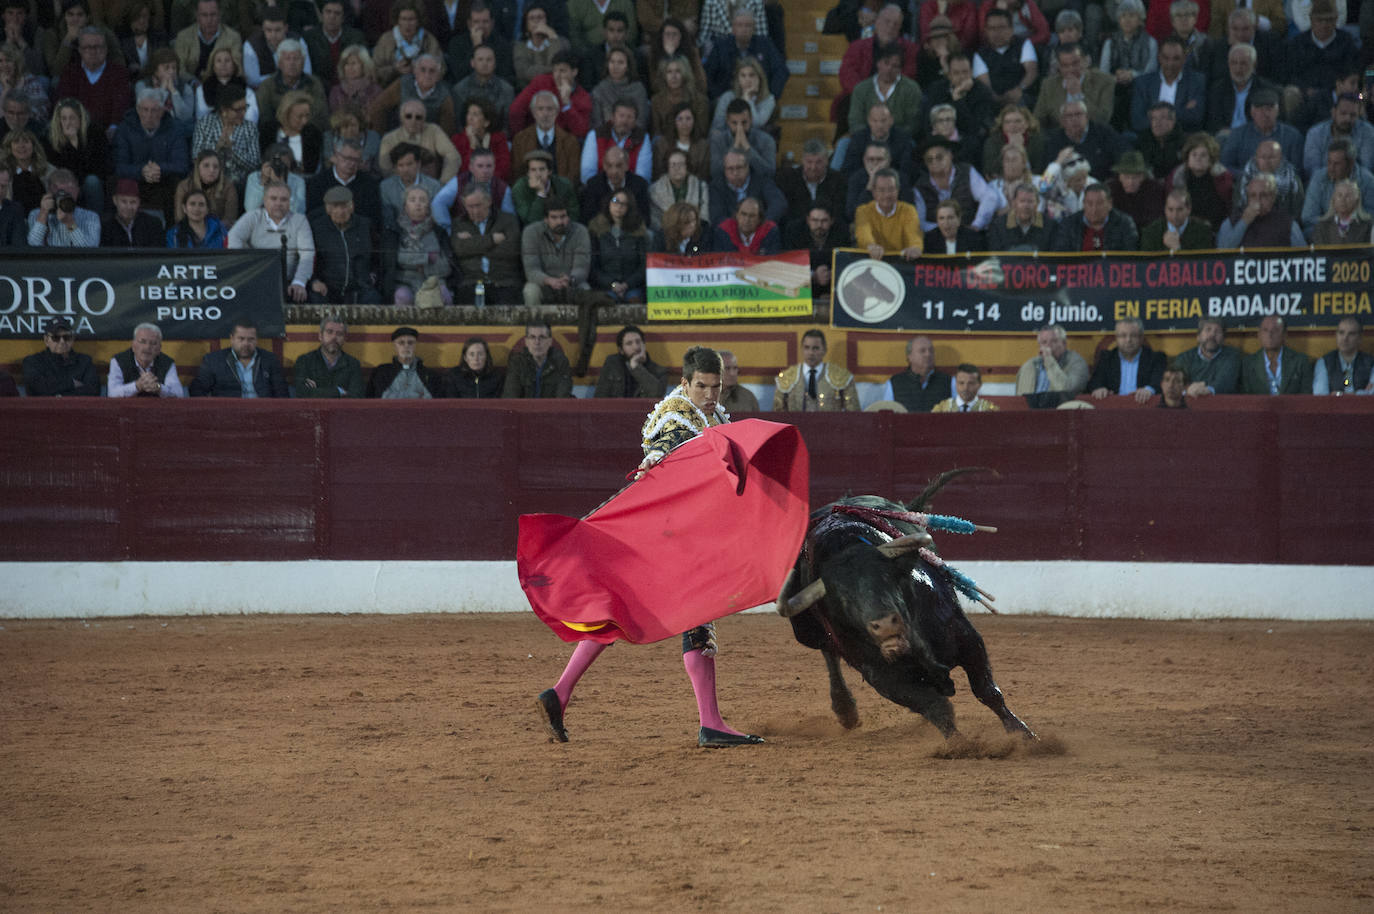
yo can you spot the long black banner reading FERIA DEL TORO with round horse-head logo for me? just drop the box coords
[830,246,1374,333]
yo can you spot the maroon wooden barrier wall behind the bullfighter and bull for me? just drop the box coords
[0,397,1374,565]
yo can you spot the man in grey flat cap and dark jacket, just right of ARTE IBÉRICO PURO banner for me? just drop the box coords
[309,187,382,305]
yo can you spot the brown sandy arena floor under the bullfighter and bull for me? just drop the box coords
[0,614,1374,913]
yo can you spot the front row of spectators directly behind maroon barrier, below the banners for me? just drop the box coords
[8,315,1374,412]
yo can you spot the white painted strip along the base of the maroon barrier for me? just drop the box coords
[0,562,1374,620]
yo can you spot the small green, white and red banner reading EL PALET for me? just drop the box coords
[647,250,812,320]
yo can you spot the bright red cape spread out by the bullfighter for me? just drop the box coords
[515,419,811,645]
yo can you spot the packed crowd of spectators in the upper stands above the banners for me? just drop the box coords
[0,0,1374,285]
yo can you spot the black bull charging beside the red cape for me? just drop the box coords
[778,495,1035,739]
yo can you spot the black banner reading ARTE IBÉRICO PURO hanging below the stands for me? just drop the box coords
[0,247,286,339]
